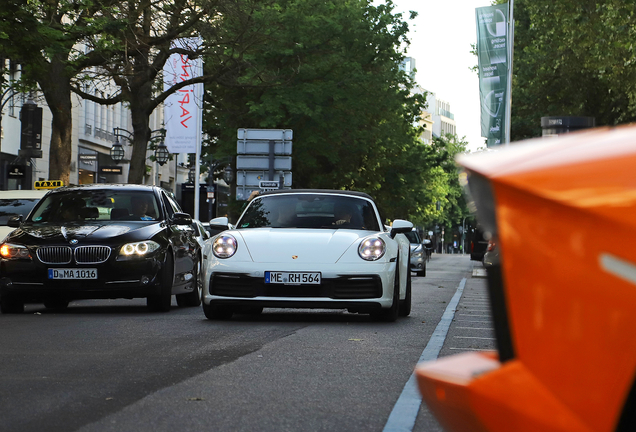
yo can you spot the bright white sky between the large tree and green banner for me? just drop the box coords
[382,0,491,151]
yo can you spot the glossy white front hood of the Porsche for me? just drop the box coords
[233,228,370,264]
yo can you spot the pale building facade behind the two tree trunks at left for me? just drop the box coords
[0,59,189,195]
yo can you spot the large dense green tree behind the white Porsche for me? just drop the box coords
[205,0,426,223]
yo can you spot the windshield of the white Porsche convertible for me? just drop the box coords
[237,194,380,231]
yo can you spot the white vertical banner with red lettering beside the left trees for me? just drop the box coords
[163,38,203,153]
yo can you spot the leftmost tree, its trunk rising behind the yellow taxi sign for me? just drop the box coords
[0,0,117,184]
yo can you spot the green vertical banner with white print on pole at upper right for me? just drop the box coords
[475,3,509,147]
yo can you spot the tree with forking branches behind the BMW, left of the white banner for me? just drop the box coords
[73,0,290,183]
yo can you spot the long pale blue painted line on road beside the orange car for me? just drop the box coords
[383,278,466,432]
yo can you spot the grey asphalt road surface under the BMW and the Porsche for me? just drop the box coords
[0,255,494,432]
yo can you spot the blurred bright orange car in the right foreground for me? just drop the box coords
[416,125,636,432]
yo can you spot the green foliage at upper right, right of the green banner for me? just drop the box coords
[497,0,636,140]
